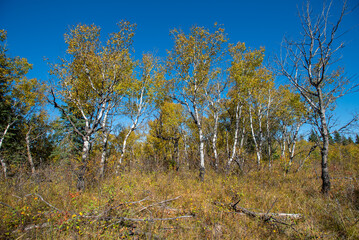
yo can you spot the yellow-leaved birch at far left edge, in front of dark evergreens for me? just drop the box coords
[0,30,44,178]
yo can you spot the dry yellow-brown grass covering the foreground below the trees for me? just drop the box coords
[0,150,359,239]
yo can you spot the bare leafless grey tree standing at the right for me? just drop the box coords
[278,2,357,194]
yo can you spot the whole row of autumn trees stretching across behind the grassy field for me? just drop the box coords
[0,1,359,193]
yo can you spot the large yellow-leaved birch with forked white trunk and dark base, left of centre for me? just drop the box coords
[49,22,135,190]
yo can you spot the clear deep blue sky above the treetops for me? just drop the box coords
[0,0,359,126]
